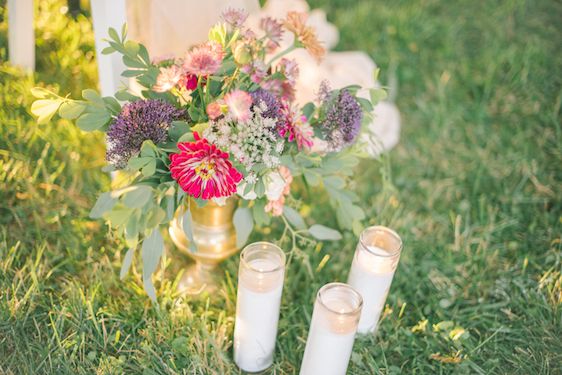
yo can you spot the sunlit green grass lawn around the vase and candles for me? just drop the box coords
[0,0,562,375]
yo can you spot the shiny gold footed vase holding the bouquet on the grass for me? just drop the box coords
[169,198,238,294]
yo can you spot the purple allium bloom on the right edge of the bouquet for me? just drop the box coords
[320,86,363,151]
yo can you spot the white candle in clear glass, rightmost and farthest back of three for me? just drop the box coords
[347,226,402,333]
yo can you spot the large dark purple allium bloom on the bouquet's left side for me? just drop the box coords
[105,99,184,169]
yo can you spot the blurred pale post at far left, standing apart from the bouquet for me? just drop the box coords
[8,0,35,70]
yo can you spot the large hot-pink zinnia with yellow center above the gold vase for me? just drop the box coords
[170,133,243,199]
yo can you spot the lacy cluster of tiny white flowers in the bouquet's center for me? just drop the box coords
[203,102,285,171]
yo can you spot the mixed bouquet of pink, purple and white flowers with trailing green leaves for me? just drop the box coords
[32,10,384,298]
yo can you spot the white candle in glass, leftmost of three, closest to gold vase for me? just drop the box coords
[234,242,285,372]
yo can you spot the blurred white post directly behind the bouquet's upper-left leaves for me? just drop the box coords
[91,0,127,96]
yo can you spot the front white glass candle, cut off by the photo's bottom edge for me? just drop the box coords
[300,283,363,375]
